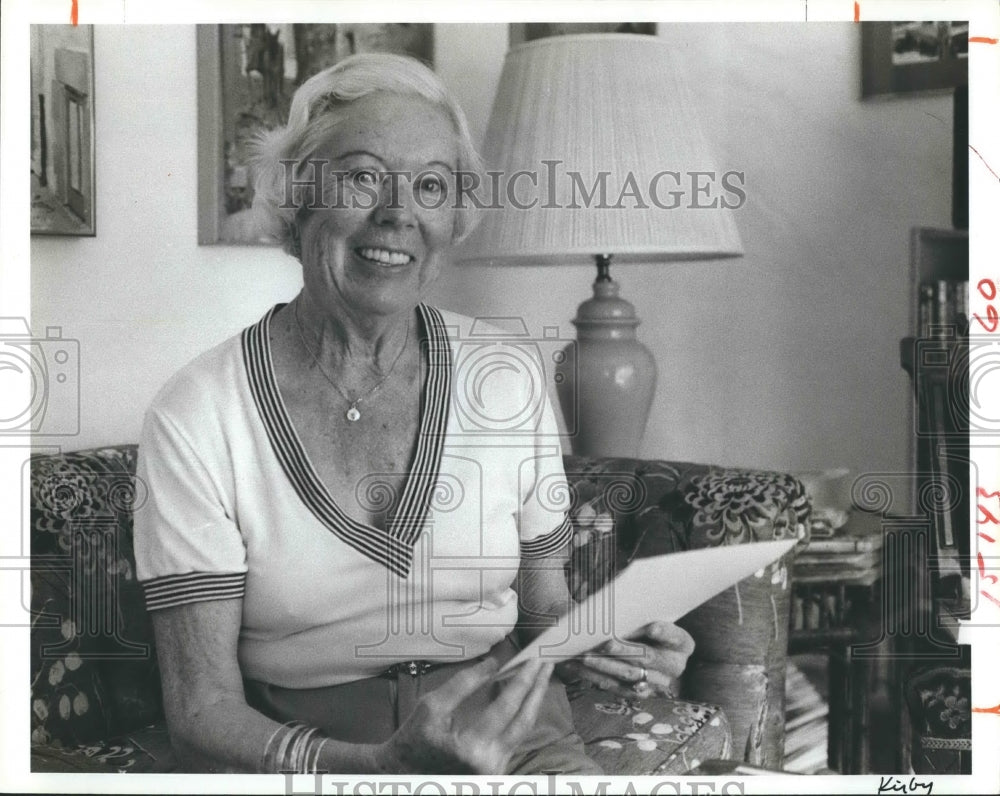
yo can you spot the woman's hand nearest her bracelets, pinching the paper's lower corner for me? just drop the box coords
[375,660,552,774]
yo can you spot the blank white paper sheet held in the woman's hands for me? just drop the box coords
[498,539,796,674]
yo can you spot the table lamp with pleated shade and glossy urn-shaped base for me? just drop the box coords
[456,33,745,456]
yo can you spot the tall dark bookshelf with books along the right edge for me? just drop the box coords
[894,227,971,773]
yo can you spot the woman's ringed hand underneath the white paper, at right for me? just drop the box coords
[559,622,694,696]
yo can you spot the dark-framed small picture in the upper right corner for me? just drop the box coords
[861,22,969,97]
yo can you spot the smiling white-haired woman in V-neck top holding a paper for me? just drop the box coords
[136,55,692,774]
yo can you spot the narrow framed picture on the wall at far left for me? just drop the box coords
[30,25,96,235]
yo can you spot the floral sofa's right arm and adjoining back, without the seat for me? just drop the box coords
[565,457,811,766]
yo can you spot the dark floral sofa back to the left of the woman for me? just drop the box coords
[24,445,163,748]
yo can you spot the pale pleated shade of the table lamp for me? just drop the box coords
[456,33,742,264]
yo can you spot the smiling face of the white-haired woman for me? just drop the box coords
[299,93,458,318]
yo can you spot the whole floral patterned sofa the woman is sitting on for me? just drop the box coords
[26,445,810,775]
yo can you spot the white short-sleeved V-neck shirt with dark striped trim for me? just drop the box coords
[135,305,570,688]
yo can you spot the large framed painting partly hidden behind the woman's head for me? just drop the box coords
[198,23,434,244]
